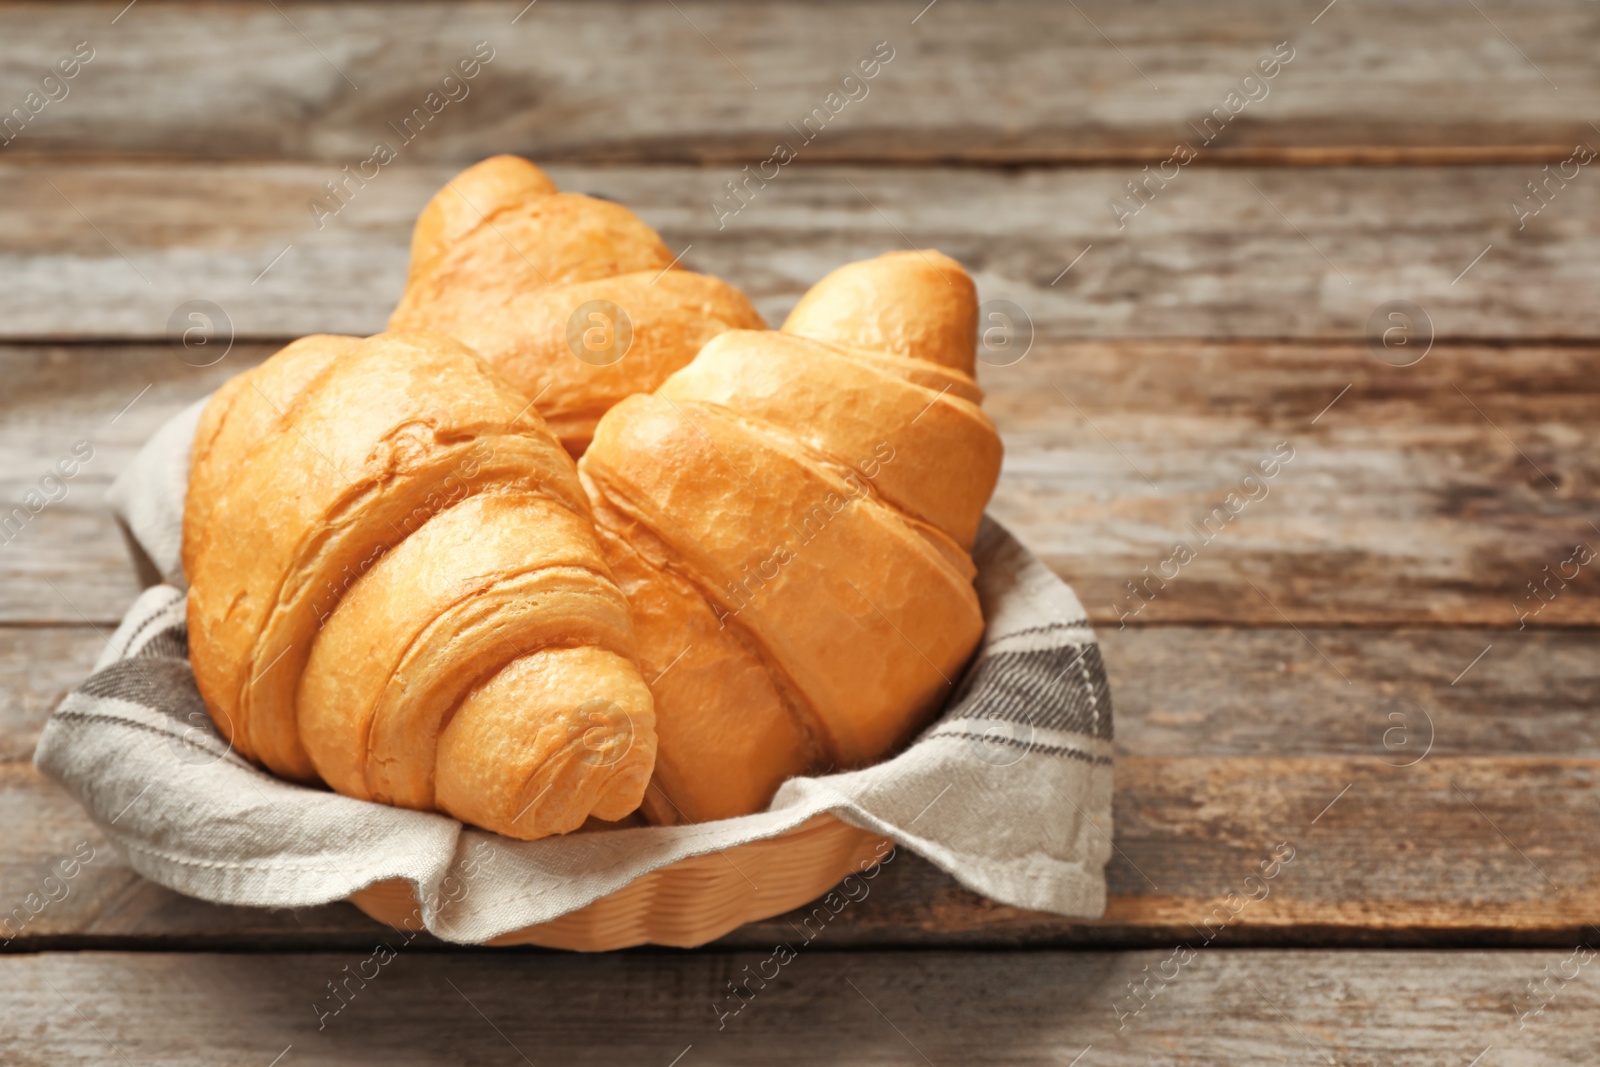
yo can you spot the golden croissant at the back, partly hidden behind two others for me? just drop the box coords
[389,155,766,456]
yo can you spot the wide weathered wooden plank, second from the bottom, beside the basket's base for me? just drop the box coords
[0,627,1600,950]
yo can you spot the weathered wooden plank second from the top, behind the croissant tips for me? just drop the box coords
[0,163,1600,339]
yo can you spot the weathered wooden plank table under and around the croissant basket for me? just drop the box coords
[0,0,1600,1067]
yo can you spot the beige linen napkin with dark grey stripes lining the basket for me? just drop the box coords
[34,402,1112,944]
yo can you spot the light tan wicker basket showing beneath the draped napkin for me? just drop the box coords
[350,814,886,952]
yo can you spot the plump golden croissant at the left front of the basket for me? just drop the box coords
[182,334,656,838]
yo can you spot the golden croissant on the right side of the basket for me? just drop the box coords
[579,251,1002,822]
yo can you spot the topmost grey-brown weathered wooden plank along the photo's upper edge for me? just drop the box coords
[0,0,1600,171]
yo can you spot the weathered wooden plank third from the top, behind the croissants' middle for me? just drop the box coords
[9,341,1600,627]
